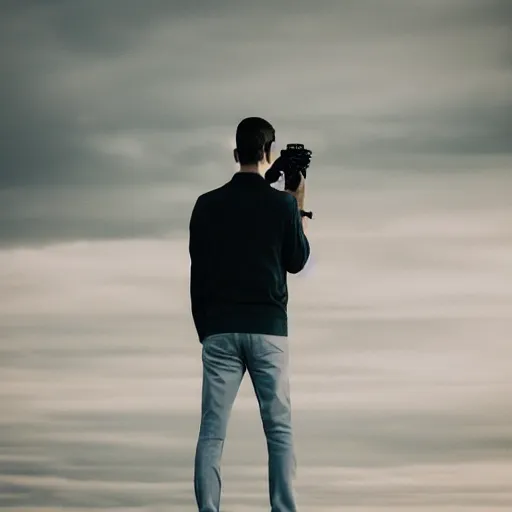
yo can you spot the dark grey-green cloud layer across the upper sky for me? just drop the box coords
[0,0,512,243]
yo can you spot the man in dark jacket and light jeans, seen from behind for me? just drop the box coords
[189,117,310,512]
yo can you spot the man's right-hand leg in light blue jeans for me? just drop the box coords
[244,334,297,512]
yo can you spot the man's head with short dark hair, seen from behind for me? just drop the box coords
[234,117,276,172]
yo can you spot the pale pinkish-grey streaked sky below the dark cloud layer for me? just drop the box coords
[0,232,512,512]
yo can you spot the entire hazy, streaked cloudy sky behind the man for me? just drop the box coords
[0,0,512,512]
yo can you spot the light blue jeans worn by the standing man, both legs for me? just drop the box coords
[194,333,297,512]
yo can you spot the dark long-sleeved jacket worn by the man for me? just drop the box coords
[189,172,310,343]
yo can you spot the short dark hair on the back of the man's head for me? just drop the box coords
[236,117,276,165]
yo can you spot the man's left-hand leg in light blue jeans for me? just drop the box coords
[194,334,245,512]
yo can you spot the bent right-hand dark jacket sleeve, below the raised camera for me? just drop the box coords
[283,194,310,274]
